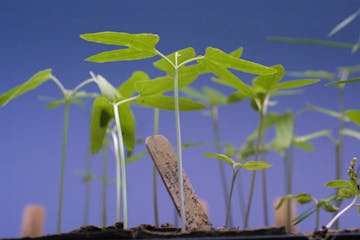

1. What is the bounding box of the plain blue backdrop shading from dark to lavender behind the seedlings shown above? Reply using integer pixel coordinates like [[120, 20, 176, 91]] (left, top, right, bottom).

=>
[[0, 0, 360, 237]]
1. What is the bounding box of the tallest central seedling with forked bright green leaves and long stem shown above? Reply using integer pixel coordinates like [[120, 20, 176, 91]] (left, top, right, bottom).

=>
[[81, 32, 275, 231]]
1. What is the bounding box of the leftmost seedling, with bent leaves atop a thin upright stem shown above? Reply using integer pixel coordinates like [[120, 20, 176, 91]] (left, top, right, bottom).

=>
[[0, 69, 99, 233]]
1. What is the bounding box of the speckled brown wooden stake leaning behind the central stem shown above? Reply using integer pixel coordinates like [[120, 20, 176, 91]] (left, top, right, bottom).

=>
[[145, 135, 212, 231]]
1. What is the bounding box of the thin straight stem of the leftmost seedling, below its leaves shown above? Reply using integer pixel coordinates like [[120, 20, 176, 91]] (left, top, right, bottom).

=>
[[57, 101, 70, 233]]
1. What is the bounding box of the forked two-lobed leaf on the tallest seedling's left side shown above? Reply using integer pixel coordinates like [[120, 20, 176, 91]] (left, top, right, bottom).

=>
[[80, 32, 159, 63]]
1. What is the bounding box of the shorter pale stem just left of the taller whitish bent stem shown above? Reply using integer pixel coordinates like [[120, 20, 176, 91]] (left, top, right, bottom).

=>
[[111, 131, 121, 222]]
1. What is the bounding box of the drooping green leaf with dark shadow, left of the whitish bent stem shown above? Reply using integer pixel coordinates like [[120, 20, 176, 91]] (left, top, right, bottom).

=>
[[90, 97, 114, 154]]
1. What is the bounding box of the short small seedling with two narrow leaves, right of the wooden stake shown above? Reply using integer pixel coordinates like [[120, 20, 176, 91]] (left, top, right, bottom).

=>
[[204, 153, 271, 227]]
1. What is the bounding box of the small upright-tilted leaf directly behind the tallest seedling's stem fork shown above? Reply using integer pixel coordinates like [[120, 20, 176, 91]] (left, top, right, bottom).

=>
[[153, 47, 196, 75]]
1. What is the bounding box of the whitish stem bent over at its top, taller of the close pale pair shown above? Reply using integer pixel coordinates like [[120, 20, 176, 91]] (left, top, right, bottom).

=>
[[113, 103, 128, 229]]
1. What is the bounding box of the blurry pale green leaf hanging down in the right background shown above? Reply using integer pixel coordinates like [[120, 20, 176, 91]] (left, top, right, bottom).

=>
[[268, 113, 294, 152]]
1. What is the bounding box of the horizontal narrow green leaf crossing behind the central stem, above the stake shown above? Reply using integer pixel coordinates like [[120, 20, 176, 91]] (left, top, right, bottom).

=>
[[136, 95, 205, 111]]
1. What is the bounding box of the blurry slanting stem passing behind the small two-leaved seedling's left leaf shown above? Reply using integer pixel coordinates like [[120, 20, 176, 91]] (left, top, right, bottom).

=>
[[210, 106, 232, 225]]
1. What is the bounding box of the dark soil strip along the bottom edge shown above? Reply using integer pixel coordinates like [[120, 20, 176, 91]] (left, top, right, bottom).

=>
[[3, 223, 360, 240]]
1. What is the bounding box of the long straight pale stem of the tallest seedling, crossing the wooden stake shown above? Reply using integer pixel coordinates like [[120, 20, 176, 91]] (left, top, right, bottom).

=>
[[174, 52, 186, 231]]
